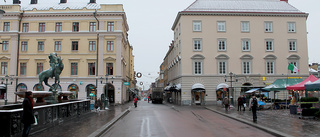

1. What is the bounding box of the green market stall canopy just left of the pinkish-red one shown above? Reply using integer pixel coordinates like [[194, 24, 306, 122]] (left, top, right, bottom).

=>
[[262, 78, 303, 91]]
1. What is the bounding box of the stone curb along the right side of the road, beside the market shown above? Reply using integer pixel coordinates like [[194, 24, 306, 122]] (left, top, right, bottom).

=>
[[205, 107, 293, 137]]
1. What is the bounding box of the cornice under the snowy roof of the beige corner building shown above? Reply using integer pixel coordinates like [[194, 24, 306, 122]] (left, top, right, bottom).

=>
[[171, 11, 309, 31]]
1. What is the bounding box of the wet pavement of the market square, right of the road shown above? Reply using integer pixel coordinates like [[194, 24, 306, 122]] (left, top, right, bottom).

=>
[[207, 106, 320, 137]]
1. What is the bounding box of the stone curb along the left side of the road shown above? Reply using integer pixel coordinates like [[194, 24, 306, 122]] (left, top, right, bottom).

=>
[[88, 109, 130, 137]]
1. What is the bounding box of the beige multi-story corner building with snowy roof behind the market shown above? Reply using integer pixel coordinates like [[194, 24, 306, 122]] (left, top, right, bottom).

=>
[[164, 0, 309, 105]]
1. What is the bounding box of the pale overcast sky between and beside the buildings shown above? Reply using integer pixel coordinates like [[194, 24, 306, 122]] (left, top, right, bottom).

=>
[[105, 0, 320, 89]]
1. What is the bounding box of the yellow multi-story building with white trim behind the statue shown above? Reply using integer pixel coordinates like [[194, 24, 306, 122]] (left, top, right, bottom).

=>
[[0, 0, 136, 104]]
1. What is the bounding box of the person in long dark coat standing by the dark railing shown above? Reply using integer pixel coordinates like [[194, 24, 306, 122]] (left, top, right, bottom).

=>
[[21, 91, 35, 137]]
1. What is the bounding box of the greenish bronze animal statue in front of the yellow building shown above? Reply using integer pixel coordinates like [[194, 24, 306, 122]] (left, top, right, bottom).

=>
[[39, 53, 63, 91]]
